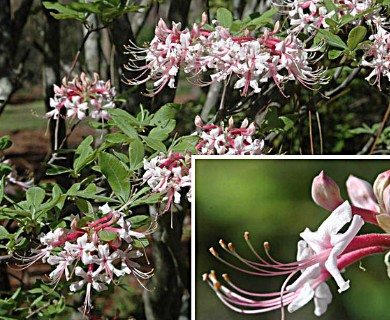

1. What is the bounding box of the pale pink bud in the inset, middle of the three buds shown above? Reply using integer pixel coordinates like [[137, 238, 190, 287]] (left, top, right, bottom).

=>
[[346, 175, 379, 212]]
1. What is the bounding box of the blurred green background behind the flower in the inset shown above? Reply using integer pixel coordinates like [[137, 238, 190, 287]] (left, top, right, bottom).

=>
[[195, 159, 390, 320]]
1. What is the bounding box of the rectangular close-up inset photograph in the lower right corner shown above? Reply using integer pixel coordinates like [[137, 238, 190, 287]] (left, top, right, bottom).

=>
[[197, 158, 390, 320]]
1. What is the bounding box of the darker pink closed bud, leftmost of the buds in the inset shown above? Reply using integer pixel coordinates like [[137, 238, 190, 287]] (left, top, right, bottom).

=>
[[311, 171, 344, 211]]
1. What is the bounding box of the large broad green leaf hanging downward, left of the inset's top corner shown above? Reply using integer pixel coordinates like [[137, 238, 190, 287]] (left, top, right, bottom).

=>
[[98, 152, 130, 202]]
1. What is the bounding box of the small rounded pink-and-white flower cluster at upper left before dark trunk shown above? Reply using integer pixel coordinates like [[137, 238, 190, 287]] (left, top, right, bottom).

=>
[[46, 73, 115, 120]]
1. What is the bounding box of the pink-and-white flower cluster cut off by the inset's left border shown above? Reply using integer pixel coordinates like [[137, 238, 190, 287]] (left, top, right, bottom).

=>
[[143, 152, 191, 213]]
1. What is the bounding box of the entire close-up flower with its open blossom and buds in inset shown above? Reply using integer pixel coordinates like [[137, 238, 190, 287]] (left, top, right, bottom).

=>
[[204, 170, 390, 318]]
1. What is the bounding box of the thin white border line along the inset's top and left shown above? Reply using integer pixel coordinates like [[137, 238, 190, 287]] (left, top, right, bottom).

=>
[[190, 155, 390, 320]]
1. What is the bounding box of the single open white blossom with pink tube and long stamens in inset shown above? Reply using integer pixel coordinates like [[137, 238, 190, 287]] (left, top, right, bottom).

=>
[[203, 202, 390, 318]]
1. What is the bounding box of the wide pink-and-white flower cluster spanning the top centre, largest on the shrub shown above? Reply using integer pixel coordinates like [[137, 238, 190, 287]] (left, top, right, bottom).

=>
[[127, 14, 327, 96]]
